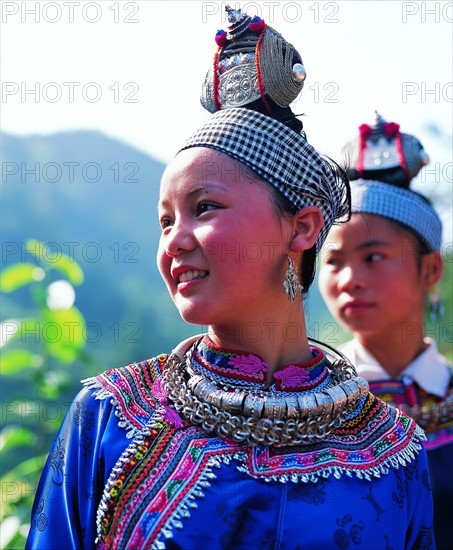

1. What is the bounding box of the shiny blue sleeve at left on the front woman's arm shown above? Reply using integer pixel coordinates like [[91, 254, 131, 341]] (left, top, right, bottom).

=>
[[26, 389, 122, 550]]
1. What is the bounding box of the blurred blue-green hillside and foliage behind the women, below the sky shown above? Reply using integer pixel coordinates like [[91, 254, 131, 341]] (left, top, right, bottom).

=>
[[0, 132, 453, 548]]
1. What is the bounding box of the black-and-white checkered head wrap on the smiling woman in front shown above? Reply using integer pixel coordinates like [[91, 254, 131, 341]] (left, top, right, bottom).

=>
[[181, 108, 349, 251]]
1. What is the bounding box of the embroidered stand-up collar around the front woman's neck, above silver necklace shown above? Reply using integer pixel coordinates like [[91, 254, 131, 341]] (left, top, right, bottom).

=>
[[191, 336, 330, 392]]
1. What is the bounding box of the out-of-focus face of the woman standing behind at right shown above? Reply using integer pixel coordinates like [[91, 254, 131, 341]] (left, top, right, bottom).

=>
[[319, 214, 428, 338]]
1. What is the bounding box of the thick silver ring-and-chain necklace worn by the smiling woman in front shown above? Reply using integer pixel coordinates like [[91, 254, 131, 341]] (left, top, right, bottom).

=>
[[162, 342, 369, 446]]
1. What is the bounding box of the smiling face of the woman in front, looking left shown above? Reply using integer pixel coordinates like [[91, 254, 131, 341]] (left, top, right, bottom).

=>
[[157, 148, 291, 325]]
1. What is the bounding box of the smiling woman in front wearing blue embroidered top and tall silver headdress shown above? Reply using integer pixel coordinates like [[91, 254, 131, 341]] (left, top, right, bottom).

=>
[[28, 9, 432, 550]]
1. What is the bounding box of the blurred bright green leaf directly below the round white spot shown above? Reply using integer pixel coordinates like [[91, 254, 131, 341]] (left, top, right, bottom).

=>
[[42, 307, 86, 363]]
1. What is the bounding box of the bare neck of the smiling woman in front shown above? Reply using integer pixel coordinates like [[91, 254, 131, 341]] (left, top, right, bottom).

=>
[[209, 304, 312, 380]]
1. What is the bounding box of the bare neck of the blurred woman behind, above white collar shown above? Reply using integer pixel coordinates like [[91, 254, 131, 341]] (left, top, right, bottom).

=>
[[354, 322, 428, 377]]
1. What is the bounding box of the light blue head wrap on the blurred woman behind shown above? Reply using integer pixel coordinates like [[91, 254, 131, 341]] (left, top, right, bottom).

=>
[[351, 179, 442, 252]]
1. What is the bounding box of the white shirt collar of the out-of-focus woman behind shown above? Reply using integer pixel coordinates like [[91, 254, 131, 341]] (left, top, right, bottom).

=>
[[341, 338, 452, 398]]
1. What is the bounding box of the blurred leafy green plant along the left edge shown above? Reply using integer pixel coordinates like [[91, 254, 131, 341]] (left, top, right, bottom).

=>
[[0, 240, 86, 548]]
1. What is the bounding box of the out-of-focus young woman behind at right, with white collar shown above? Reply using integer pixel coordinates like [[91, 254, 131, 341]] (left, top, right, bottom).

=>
[[319, 117, 453, 549]]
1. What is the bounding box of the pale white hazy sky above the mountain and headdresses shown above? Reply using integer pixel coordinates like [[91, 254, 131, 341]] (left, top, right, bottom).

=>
[[0, 0, 453, 170]]
